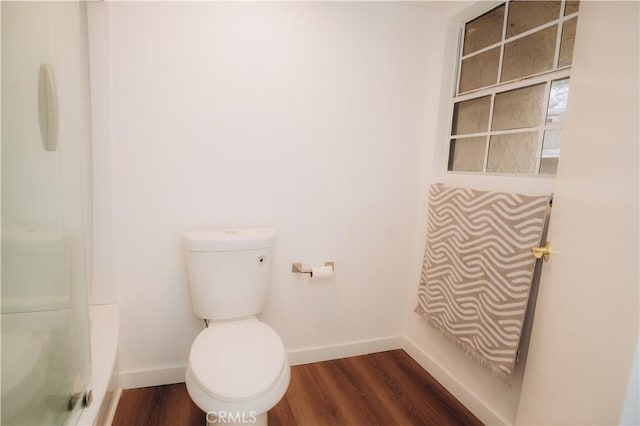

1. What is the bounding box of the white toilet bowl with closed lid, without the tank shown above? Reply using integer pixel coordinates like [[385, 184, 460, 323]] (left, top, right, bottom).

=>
[[186, 318, 290, 425]]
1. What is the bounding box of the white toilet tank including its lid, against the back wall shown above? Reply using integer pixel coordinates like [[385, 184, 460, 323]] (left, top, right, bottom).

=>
[[182, 228, 276, 320]]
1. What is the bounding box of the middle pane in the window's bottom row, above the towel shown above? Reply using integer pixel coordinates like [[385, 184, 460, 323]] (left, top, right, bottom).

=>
[[487, 132, 538, 174]]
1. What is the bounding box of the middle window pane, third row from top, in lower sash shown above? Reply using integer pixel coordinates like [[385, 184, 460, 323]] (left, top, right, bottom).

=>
[[491, 83, 545, 130]]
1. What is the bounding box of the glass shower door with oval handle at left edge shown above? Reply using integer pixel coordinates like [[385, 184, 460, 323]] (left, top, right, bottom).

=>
[[0, 1, 91, 425]]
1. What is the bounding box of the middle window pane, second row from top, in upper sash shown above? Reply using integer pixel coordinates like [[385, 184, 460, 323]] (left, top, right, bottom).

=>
[[502, 25, 558, 81]]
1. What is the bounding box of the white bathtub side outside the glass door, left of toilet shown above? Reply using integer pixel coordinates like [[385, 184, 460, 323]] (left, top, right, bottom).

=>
[[78, 304, 120, 426]]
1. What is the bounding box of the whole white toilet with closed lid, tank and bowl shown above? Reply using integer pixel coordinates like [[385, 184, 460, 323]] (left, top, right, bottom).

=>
[[183, 228, 291, 426]]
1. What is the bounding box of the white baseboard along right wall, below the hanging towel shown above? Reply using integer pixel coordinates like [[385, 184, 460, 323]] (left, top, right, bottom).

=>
[[402, 337, 509, 425]]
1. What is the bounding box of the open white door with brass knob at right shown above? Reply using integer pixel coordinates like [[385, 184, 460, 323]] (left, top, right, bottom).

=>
[[517, 2, 640, 425]]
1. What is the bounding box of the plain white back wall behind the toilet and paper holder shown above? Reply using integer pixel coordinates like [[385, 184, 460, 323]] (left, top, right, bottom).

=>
[[96, 3, 444, 386]]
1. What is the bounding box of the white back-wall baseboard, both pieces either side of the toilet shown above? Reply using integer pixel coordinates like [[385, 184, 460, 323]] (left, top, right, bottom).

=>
[[120, 336, 404, 389]]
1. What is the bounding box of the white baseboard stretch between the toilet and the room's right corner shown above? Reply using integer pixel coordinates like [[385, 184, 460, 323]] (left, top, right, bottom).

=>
[[287, 336, 404, 365]]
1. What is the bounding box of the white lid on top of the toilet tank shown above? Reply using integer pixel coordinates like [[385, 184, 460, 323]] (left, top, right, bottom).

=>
[[182, 227, 276, 251]]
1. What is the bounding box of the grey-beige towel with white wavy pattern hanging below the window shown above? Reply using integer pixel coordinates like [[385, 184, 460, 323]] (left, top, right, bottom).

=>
[[415, 184, 550, 383]]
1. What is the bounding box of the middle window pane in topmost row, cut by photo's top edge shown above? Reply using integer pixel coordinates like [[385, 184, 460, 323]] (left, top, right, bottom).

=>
[[507, 1, 560, 38]]
